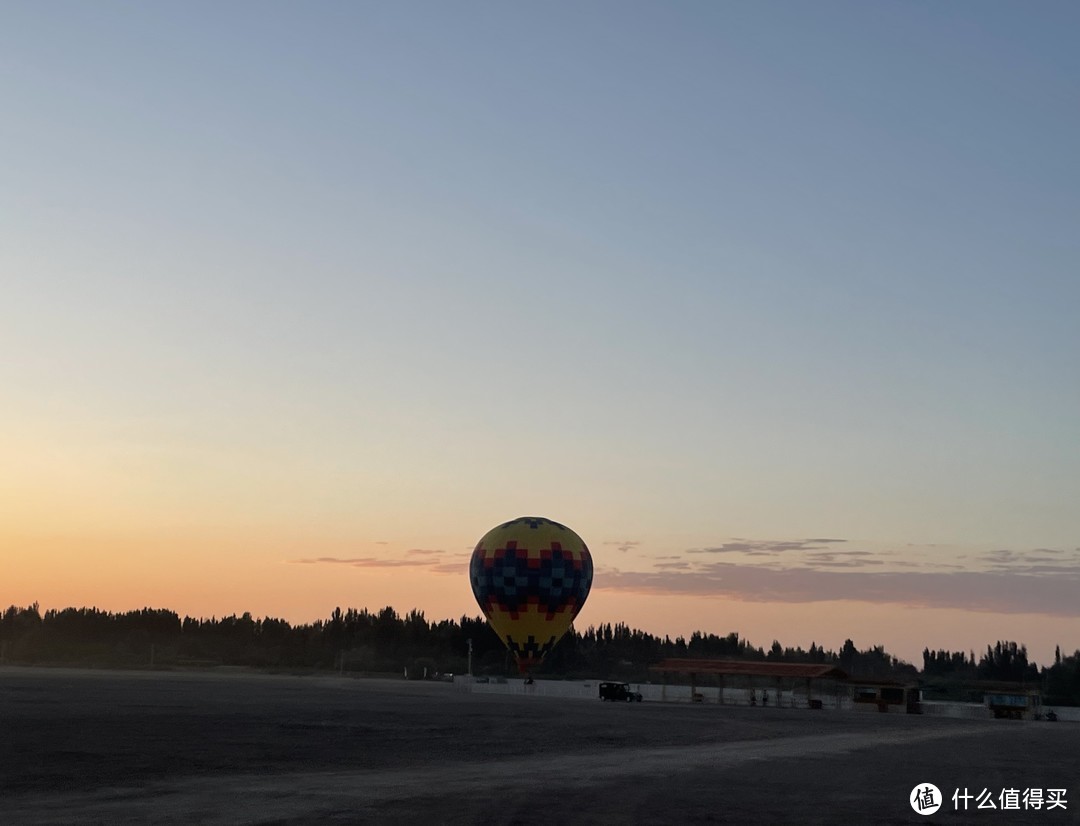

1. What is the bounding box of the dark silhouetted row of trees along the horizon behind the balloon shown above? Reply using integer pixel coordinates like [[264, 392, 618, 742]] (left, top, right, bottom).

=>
[[0, 604, 1080, 705]]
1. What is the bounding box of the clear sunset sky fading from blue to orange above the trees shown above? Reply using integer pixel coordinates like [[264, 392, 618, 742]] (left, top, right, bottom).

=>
[[0, 0, 1080, 665]]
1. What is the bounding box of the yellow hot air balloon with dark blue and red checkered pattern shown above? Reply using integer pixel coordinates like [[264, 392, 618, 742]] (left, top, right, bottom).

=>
[[469, 516, 593, 674]]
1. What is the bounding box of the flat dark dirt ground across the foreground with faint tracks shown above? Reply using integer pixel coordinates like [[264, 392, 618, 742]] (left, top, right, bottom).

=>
[[0, 666, 1080, 825]]
